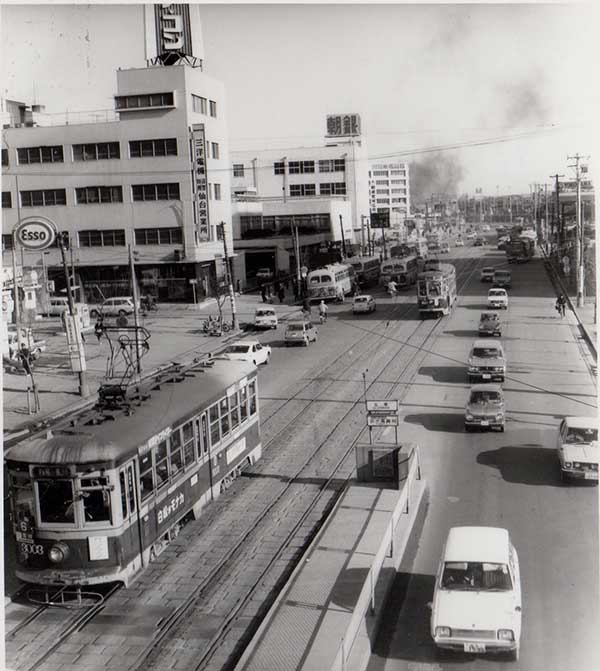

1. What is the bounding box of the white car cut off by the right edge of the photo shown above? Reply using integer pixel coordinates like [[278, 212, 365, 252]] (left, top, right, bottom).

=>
[[556, 417, 599, 483]]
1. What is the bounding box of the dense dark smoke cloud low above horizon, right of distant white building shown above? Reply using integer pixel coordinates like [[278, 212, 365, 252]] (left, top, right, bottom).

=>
[[409, 152, 464, 205]]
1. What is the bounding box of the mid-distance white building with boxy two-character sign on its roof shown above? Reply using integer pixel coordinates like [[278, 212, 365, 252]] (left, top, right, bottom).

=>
[[231, 115, 369, 278]]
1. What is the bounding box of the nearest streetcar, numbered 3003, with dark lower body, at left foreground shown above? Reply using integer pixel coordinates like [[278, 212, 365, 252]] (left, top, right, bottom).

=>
[[5, 360, 262, 589]]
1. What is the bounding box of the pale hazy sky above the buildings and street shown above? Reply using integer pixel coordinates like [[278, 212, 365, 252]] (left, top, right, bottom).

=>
[[1, 2, 600, 194]]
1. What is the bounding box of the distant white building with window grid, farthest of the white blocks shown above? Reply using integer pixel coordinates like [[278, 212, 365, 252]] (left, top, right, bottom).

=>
[[369, 161, 410, 227]]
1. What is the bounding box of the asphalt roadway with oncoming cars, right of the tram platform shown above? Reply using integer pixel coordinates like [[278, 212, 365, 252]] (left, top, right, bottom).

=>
[[360, 240, 600, 671]]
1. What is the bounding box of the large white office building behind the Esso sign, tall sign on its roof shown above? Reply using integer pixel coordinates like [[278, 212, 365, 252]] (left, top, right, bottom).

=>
[[2, 5, 232, 300]]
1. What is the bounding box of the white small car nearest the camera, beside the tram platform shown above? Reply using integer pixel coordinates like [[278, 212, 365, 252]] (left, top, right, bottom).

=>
[[430, 526, 522, 660]]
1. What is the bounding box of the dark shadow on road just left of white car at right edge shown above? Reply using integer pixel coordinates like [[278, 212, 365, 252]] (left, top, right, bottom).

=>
[[477, 444, 562, 487]]
